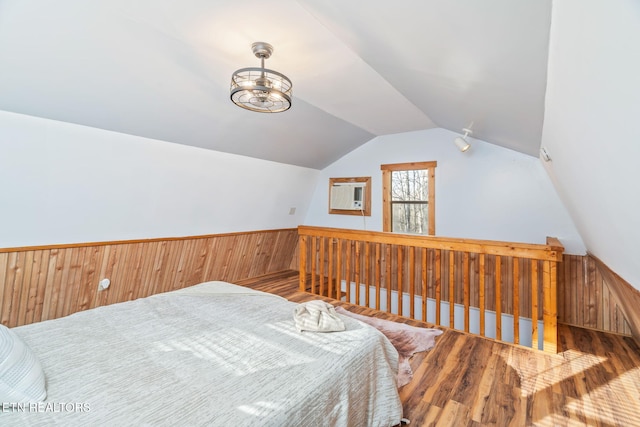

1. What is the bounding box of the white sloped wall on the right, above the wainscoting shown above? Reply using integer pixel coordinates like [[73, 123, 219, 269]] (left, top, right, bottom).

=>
[[542, 0, 640, 289]]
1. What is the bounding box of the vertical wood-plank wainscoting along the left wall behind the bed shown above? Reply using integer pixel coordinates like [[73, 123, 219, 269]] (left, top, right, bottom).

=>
[[0, 229, 298, 327]]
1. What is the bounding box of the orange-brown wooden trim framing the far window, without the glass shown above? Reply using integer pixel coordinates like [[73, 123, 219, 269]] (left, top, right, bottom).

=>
[[380, 161, 438, 236]]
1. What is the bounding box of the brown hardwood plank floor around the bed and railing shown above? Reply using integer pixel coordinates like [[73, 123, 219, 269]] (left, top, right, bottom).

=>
[[236, 270, 640, 427]]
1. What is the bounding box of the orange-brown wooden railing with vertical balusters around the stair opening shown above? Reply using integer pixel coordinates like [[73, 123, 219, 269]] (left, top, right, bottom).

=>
[[298, 226, 564, 353]]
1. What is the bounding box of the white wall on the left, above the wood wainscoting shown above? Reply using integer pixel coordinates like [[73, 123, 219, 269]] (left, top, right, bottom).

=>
[[0, 111, 319, 247]]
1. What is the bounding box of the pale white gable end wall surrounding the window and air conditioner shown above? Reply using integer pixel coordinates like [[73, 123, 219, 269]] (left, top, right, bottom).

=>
[[305, 129, 585, 254]]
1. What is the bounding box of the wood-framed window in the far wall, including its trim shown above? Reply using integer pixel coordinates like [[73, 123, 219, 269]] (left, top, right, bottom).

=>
[[380, 162, 437, 235]]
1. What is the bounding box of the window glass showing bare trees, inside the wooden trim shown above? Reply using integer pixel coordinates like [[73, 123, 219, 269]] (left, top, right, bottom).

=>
[[391, 169, 429, 234]]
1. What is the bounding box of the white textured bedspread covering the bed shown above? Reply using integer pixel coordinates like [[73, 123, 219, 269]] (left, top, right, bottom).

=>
[[0, 282, 402, 426]]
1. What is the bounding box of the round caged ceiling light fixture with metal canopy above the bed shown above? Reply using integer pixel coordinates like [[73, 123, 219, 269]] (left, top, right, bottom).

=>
[[231, 42, 292, 113]]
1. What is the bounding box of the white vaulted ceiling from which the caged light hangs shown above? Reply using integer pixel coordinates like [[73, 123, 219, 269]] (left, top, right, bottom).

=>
[[0, 0, 551, 169]]
